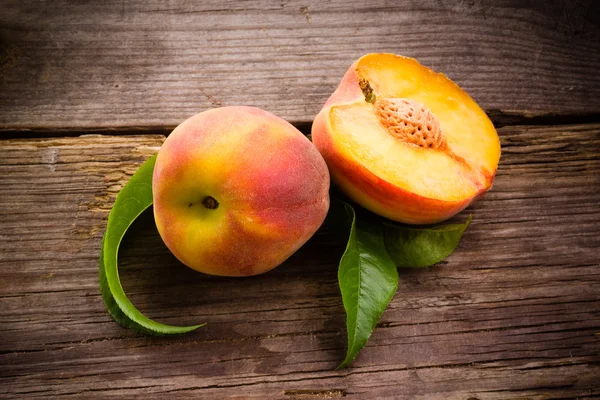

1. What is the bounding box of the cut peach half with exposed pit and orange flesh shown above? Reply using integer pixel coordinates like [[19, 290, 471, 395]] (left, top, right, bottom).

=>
[[312, 54, 500, 224]]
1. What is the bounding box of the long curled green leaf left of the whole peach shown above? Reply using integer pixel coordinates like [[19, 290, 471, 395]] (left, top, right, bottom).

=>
[[100, 155, 204, 335]]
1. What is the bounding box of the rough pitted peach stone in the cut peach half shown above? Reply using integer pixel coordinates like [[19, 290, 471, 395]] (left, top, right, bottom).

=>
[[375, 98, 446, 149]]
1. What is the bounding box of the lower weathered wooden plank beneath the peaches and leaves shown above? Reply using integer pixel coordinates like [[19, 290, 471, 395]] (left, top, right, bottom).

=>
[[0, 124, 600, 400]]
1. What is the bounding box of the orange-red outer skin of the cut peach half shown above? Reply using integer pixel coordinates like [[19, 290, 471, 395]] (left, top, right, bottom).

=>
[[311, 61, 494, 224]]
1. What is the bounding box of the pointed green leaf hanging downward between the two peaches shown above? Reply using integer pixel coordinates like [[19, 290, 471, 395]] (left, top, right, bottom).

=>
[[338, 204, 398, 368]]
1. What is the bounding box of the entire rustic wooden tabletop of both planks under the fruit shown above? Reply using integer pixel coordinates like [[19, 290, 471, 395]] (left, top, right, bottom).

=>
[[0, 0, 600, 400]]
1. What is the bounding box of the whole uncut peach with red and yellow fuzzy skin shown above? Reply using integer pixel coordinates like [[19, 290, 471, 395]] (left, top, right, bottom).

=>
[[152, 107, 329, 276]]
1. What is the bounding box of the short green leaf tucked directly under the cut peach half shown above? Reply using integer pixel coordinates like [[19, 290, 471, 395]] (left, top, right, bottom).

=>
[[384, 216, 472, 267]]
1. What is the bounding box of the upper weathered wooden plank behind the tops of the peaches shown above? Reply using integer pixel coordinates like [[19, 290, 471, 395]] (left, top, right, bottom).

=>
[[0, 0, 600, 130]]
